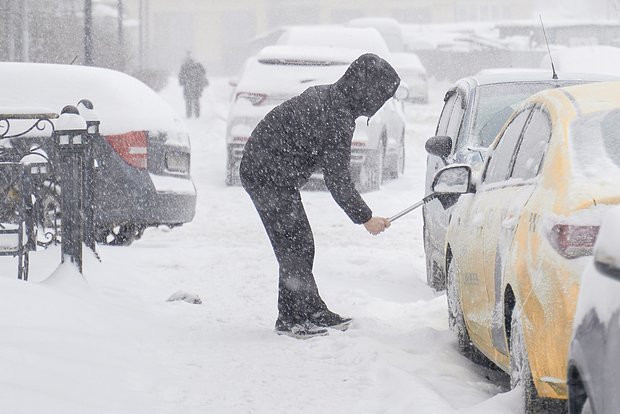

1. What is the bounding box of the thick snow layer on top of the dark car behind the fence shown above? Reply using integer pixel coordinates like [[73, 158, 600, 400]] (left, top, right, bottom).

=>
[[0, 62, 185, 134]]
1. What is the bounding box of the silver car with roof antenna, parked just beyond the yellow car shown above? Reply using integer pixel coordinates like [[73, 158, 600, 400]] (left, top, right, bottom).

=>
[[423, 70, 612, 290]]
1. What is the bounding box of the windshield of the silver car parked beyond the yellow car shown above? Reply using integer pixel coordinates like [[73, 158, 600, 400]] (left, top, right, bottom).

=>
[[471, 82, 576, 148]]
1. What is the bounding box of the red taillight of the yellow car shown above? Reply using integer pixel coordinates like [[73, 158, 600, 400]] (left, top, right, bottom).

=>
[[549, 224, 599, 259]]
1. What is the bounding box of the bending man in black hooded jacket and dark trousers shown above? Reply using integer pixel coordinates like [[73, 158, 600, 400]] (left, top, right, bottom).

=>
[[240, 53, 400, 337]]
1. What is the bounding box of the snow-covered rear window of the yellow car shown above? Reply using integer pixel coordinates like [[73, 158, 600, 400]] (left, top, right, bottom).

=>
[[570, 109, 620, 184]]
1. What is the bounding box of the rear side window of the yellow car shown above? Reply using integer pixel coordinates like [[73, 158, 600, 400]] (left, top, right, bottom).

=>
[[511, 108, 551, 180]]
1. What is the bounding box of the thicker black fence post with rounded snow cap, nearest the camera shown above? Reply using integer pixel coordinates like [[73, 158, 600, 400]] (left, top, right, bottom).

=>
[[54, 105, 87, 273]]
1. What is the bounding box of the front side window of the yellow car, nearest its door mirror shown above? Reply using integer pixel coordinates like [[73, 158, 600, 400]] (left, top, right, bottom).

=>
[[484, 108, 531, 183]]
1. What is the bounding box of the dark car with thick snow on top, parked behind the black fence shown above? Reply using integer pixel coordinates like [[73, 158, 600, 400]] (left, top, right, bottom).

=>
[[0, 62, 196, 244]]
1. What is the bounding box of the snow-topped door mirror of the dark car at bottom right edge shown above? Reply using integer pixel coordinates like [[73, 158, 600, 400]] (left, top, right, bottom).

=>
[[594, 208, 620, 280]]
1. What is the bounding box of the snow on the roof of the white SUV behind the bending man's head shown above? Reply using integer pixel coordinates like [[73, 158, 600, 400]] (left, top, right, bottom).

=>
[[278, 26, 390, 58]]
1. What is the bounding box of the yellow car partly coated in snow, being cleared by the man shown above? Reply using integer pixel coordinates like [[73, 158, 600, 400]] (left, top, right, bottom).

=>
[[438, 82, 620, 413]]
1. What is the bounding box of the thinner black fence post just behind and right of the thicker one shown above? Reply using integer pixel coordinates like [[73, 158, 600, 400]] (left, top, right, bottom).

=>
[[77, 99, 101, 253]]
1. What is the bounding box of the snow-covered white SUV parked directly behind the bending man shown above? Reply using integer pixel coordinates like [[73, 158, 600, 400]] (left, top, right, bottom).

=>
[[226, 27, 406, 191]]
